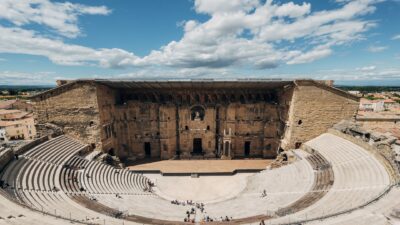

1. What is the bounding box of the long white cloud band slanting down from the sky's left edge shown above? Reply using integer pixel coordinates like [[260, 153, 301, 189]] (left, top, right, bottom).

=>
[[0, 26, 140, 67]]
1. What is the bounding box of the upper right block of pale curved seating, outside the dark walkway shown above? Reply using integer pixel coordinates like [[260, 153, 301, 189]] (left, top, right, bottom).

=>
[[272, 133, 391, 224]]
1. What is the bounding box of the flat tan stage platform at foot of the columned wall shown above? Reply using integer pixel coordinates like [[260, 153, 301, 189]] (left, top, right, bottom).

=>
[[128, 159, 273, 176]]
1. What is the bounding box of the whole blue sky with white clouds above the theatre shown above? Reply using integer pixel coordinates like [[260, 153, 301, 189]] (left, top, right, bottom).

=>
[[0, 0, 400, 85]]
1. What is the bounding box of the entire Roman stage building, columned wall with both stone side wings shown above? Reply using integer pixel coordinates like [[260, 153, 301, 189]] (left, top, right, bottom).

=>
[[33, 80, 358, 159]]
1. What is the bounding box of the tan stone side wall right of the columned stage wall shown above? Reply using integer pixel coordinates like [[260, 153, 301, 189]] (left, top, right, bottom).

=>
[[281, 80, 359, 149]]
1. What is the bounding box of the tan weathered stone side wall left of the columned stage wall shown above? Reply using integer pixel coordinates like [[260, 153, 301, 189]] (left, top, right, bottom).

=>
[[32, 82, 102, 149]]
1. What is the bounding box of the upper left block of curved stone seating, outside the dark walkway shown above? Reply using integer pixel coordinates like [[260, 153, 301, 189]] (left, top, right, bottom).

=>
[[1, 136, 150, 224]]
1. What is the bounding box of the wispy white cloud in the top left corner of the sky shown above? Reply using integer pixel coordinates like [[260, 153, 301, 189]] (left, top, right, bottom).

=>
[[0, 0, 110, 38]]
